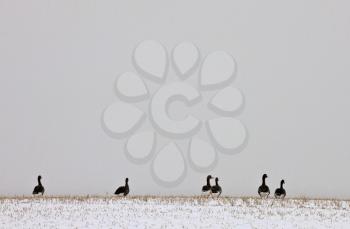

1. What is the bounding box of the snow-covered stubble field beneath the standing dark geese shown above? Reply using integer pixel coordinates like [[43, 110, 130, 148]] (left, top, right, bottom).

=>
[[0, 197, 350, 229]]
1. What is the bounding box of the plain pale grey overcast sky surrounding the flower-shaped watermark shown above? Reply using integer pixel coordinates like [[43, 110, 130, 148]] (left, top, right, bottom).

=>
[[0, 0, 350, 198]]
